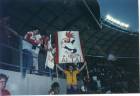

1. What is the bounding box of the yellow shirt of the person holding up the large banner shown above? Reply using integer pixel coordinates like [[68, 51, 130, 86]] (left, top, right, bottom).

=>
[[64, 70, 79, 85]]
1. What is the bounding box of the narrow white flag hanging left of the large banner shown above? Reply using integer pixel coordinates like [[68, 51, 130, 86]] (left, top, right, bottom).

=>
[[45, 35, 54, 69]]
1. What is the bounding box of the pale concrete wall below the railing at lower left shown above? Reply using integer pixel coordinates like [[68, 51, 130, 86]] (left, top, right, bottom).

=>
[[0, 69, 66, 95]]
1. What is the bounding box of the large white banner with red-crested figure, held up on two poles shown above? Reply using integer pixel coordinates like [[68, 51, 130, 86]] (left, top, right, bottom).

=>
[[55, 31, 84, 63]]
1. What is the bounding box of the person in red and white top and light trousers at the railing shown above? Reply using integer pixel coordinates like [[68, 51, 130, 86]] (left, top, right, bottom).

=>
[[23, 26, 42, 72]]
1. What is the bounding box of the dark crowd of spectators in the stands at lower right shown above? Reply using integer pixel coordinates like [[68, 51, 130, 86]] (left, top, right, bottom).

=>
[[80, 63, 138, 93]]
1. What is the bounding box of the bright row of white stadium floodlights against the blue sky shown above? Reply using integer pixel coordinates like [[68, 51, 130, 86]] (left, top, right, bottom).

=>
[[105, 14, 129, 28]]
